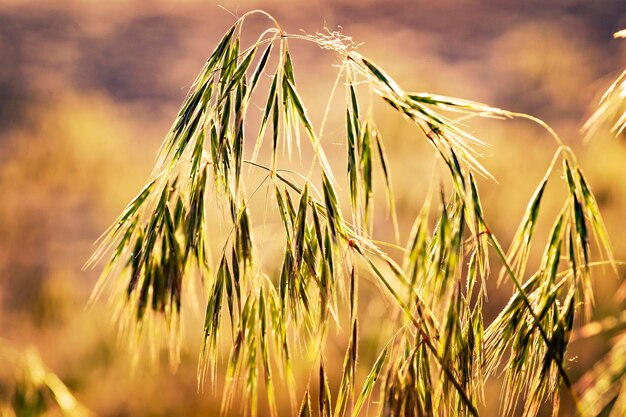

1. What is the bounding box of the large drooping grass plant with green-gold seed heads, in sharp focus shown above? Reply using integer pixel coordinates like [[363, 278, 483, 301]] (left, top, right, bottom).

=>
[[86, 11, 625, 417]]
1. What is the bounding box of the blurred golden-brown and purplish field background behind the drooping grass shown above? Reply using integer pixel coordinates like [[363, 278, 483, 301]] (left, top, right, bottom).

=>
[[0, 0, 626, 417]]
